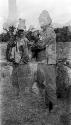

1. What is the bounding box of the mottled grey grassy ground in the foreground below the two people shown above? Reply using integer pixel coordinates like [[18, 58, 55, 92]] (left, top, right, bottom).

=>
[[0, 63, 65, 125]]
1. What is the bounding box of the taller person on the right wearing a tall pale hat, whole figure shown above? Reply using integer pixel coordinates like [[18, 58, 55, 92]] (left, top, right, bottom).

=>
[[32, 10, 57, 111]]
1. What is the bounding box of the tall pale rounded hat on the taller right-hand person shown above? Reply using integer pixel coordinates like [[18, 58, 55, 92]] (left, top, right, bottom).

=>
[[39, 10, 52, 26]]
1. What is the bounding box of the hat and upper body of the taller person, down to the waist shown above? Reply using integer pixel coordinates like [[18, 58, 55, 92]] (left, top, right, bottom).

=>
[[39, 10, 56, 64]]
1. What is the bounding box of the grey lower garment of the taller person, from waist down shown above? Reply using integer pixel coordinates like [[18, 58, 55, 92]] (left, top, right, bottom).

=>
[[37, 63, 57, 104]]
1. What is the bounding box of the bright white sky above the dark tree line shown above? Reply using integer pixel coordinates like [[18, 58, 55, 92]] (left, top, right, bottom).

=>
[[0, 0, 71, 30]]
